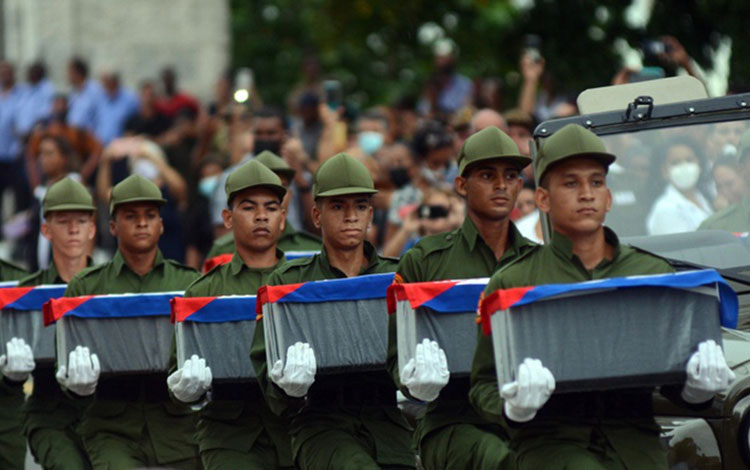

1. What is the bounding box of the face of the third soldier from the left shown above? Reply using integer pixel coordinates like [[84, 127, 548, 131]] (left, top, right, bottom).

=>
[[222, 188, 286, 253]]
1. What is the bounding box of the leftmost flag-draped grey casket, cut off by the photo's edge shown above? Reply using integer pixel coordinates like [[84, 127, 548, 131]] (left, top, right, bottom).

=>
[[0, 283, 65, 363]]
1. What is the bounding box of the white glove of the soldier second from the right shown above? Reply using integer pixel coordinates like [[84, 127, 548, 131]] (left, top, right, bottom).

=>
[[400, 339, 451, 402]]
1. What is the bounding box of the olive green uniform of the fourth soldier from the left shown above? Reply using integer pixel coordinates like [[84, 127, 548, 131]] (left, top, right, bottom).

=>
[[251, 242, 414, 468]]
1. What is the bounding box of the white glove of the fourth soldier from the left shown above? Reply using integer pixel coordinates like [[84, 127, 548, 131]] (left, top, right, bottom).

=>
[[268, 343, 318, 398]]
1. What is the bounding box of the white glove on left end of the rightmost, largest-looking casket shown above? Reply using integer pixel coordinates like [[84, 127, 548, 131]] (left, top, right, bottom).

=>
[[500, 358, 555, 423]]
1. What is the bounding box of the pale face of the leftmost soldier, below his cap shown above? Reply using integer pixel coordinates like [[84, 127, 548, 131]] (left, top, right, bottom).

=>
[[41, 211, 96, 258]]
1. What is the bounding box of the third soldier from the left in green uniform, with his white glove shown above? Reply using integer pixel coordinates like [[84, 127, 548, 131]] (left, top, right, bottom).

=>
[[168, 160, 293, 470]]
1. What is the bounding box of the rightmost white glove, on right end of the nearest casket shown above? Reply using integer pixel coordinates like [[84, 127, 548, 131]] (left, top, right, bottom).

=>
[[682, 339, 735, 404]]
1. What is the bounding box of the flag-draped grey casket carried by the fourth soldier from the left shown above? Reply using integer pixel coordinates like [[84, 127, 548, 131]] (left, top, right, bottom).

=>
[[257, 273, 393, 374]]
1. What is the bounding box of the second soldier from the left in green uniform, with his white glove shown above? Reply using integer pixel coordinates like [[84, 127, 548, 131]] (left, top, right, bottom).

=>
[[57, 175, 200, 469]]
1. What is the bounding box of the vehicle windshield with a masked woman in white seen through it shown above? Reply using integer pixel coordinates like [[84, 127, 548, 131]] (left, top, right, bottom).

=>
[[602, 120, 750, 244]]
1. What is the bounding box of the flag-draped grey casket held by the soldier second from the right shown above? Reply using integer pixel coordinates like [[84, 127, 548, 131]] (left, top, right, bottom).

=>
[[388, 278, 488, 376]]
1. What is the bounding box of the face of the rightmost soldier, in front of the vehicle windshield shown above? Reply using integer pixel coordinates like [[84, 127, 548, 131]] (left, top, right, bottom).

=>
[[535, 157, 612, 236]]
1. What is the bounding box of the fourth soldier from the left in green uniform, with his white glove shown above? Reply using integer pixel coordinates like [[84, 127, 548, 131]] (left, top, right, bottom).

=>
[[251, 154, 415, 469]]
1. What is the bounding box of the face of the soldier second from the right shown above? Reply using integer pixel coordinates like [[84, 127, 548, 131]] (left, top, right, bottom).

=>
[[454, 160, 522, 220]]
